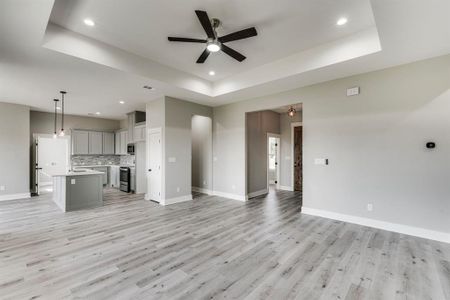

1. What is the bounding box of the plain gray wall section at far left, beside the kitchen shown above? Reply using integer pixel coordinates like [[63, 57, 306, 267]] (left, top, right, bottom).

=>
[[0, 102, 30, 196]]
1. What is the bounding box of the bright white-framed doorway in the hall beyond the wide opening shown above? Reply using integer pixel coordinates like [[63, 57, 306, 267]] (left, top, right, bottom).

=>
[[267, 133, 280, 189]]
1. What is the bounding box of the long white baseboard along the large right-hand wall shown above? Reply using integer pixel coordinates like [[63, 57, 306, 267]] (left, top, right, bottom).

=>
[[302, 207, 450, 243]]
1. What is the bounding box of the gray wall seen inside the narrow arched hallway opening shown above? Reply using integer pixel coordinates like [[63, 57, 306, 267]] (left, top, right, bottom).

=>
[[191, 116, 212, 190]]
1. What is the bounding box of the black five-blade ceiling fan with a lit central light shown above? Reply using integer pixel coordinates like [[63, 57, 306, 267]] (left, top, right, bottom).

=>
[[168, 10, 258, 64]]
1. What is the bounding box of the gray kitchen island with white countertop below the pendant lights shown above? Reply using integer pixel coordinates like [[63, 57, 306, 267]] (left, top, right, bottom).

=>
[[52, 169, 104, 212]]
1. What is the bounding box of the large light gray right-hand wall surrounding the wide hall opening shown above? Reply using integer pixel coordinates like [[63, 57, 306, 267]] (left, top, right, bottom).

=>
[[213, 56, 450, 232]]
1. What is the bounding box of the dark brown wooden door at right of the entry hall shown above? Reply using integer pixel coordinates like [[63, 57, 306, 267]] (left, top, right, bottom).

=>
[[291, 123, 303, 192]]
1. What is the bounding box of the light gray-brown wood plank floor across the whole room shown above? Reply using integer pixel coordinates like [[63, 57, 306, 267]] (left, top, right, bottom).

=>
[[0, 190, 450, 299]]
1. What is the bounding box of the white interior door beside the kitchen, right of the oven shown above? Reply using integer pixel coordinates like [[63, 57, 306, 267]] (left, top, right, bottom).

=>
[[147, 130, 162, 202]]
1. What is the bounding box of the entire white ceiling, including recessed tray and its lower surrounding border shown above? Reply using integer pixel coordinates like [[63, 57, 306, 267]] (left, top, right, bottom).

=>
[[0, 0, 450, 119]]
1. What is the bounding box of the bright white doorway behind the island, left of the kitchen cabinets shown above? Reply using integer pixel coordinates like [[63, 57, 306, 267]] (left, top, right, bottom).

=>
[[34, 134, 70, 195]]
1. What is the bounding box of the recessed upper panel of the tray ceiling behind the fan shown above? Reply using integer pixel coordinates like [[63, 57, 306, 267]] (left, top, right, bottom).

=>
[[50, 0, 375, 81]]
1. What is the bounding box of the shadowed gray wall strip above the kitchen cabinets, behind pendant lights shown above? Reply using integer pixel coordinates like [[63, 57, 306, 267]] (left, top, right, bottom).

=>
[[30, 111, 120, 139]]
